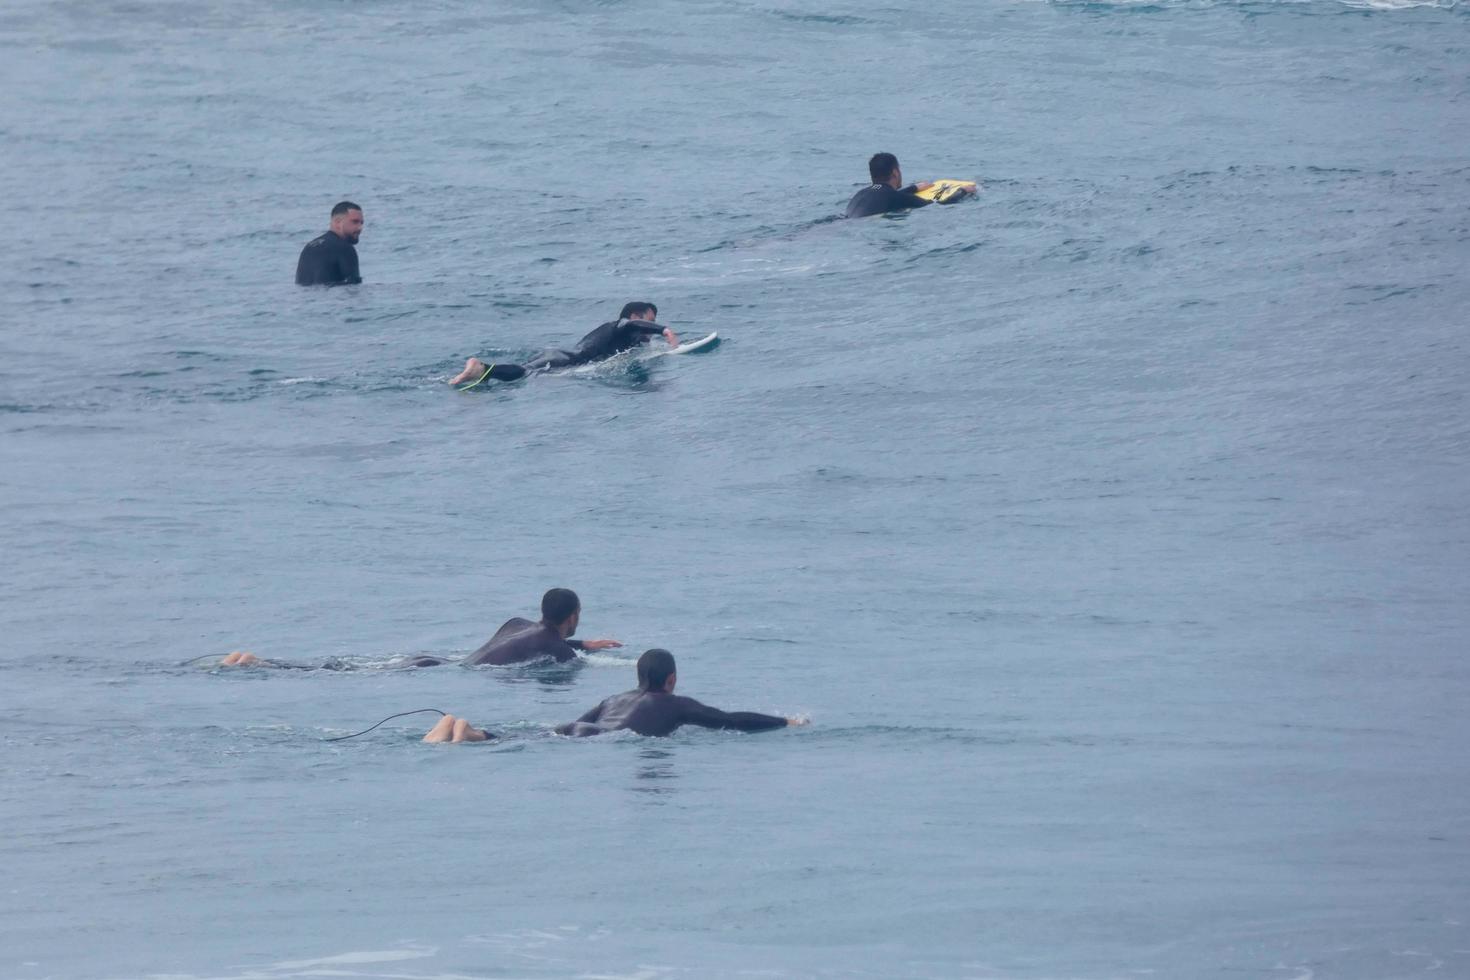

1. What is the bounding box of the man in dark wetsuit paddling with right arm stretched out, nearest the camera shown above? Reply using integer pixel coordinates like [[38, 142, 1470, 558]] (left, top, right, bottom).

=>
[[423, 649, 807, 742]]
